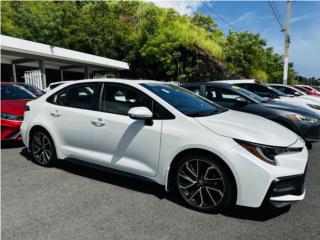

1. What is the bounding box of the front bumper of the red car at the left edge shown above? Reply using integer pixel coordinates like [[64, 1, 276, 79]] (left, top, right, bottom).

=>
[[1, 119, 22, 141]]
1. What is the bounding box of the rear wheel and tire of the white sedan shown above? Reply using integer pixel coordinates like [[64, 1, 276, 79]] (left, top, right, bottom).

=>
[[30, 130, 57, 167]]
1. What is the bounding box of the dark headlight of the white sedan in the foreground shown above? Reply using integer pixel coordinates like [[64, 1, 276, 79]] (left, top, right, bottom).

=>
[[234, 139, 289, 165]]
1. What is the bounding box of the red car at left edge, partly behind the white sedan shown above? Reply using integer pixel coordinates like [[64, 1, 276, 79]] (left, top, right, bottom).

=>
[[0, 82, 36, 141]]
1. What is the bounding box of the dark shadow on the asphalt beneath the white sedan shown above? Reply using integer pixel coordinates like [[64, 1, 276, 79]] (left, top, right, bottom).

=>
[[20, 148, 289, 221]]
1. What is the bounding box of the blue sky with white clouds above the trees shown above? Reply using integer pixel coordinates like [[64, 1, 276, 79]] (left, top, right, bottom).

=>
[[152, 0, 320, 78]]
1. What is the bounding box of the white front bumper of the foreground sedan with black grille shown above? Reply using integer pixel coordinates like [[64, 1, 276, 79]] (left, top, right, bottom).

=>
[[224, 140, 308, 207]]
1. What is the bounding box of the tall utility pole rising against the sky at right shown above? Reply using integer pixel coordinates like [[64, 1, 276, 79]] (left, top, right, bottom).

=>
[[283, 0, 291, 85]]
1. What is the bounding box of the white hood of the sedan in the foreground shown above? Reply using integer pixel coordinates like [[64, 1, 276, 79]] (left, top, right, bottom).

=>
[[196, 110, 298, 147]]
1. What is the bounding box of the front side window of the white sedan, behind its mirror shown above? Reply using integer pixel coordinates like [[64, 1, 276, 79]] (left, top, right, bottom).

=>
[[100, 84, 174, 119]]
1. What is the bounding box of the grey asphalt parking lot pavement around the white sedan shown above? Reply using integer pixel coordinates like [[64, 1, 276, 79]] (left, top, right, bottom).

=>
[[1, 144, 320, 240]]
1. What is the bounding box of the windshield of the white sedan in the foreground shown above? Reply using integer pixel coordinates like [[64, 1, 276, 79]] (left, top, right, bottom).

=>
[[141, 83, 227, 117]]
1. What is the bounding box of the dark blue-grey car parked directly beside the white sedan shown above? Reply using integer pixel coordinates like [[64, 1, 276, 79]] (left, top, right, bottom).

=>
[[182, 83, 320, 148]]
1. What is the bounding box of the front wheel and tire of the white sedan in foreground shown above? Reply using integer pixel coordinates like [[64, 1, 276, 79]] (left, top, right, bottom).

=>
[[174, 155, 235, 212]]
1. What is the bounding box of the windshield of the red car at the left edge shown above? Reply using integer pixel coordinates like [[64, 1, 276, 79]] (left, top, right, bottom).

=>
[[1, 85, 36, 100]]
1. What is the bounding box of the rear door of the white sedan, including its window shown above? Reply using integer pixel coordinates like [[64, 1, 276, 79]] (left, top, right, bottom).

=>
[[46, 83, 99, 160]]
